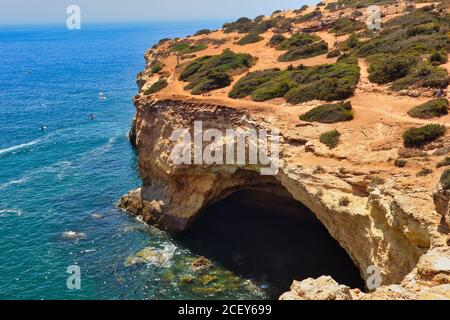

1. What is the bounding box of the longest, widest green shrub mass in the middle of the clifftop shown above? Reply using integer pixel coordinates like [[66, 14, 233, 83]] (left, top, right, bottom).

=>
[[229, 59, 359, 104]]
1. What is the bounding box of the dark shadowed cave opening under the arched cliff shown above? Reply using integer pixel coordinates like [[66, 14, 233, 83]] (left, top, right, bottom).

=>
[[179, 186, 364, 299]]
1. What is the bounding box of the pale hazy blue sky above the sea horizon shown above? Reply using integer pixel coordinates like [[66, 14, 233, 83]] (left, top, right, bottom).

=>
[[0, 0, 319, 24]]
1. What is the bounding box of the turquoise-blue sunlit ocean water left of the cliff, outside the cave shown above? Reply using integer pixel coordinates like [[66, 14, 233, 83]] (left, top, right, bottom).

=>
[[0, 22, 265, 299]]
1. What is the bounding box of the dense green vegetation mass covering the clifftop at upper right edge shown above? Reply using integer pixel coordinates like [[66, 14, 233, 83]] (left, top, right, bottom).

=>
[[353, 7, 450, 91]]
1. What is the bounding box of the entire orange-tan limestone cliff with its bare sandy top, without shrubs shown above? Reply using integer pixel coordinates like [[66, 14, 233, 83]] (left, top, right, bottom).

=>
[[119, 0, 450, 299]]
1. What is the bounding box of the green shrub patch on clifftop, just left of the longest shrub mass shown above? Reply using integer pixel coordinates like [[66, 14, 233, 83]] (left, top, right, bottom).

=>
[[180, 50, 254, 94]]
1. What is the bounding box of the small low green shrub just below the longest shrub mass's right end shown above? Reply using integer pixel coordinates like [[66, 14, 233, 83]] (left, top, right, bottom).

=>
[[300, 102, 353, 123]]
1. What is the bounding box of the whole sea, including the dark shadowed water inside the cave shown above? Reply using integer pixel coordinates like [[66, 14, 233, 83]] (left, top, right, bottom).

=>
[[0, 21, 363, 300]]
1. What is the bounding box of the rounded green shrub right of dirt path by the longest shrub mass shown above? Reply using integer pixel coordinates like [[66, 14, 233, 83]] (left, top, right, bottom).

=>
[[368, 54, 417, 83]]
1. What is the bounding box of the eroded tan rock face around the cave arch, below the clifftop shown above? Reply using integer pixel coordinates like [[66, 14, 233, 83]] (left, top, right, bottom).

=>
[[120, 95, 450, 299]]
